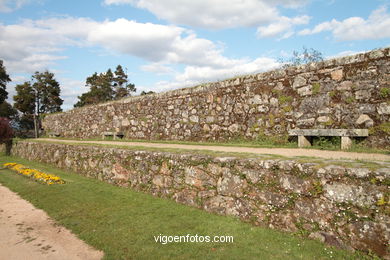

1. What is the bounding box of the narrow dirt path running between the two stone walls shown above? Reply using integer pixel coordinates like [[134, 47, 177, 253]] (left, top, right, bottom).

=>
[[39, 138, 390, 162]]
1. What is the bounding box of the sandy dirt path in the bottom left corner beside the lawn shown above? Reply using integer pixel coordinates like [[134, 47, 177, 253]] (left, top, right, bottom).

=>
[[0, 185, 103, 260]]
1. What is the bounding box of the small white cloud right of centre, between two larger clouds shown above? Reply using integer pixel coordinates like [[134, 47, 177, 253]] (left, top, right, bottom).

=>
[[257, 15, 310, 38]]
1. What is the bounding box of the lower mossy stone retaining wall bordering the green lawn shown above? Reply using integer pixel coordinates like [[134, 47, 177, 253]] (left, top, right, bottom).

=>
[[12, 141, 390, 258]]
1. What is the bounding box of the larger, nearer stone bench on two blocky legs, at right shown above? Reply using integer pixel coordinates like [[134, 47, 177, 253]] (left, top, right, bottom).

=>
[[288, 129, 368, 150]]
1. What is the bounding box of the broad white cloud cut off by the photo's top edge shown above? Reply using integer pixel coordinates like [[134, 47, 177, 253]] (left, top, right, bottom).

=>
[[104, 0, 308, 29]]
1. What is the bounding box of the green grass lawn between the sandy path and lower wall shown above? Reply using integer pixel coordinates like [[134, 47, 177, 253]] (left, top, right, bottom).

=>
[[0, 156, 372, 259]]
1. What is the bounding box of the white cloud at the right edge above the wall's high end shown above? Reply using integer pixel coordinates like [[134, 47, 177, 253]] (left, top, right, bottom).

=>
[[299, 6, 390, 41]]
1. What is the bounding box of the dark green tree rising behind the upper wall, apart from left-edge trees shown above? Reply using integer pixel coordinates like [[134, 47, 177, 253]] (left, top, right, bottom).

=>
[[74, 65, 136, 107]]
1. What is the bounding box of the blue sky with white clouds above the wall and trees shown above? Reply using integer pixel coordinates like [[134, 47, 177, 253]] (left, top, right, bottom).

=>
[[0, 0, 390, 110]]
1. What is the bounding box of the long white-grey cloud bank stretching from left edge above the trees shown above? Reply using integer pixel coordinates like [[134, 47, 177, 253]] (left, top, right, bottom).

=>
[[0, 17, 266, 72]]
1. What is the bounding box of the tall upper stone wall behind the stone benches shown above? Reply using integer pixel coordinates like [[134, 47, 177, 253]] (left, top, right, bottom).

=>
[[43, 48, 390, 146]]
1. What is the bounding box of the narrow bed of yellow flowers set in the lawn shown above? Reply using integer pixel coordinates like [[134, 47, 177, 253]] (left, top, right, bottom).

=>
[[3, 163, 65, 185]]
